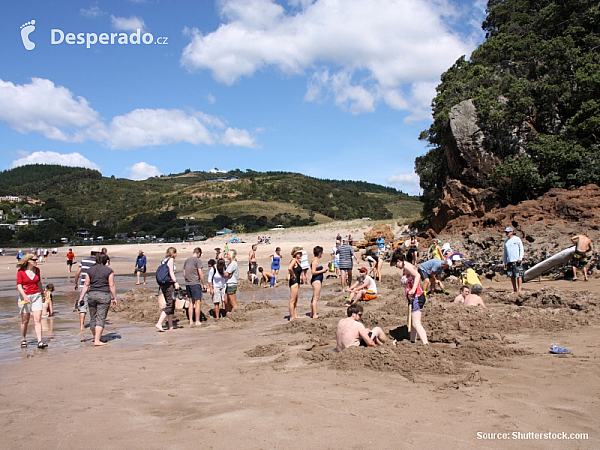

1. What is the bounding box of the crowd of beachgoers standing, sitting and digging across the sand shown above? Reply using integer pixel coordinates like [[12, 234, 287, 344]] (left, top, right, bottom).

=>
[[17, 226, 593, 351]]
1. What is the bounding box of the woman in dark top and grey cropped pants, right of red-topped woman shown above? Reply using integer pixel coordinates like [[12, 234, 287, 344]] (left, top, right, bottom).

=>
[[79, 253, 117, 347]]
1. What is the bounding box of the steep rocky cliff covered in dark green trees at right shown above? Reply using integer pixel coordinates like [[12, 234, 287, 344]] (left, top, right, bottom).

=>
[[415, 0, 600, 226]]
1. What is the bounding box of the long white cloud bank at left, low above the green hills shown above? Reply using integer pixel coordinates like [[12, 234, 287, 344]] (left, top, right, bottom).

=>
[[0, 78, 257, 149]]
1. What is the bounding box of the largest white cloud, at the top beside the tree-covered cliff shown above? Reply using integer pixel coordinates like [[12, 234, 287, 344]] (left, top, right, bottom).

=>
[[181, 0, 485, 120]]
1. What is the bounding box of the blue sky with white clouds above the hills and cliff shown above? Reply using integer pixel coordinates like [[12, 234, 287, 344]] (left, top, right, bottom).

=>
[[0, 0, 485, 194]]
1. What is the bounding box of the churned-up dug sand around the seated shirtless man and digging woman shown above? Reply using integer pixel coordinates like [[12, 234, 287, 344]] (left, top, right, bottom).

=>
[[275, 289, 599, 385]]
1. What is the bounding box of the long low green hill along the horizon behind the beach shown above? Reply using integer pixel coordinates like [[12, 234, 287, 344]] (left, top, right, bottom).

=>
[[0, 165, 422, 242]]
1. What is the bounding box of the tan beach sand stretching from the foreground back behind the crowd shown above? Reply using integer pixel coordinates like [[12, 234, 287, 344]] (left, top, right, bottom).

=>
[[0, 222, 600, 449]]
